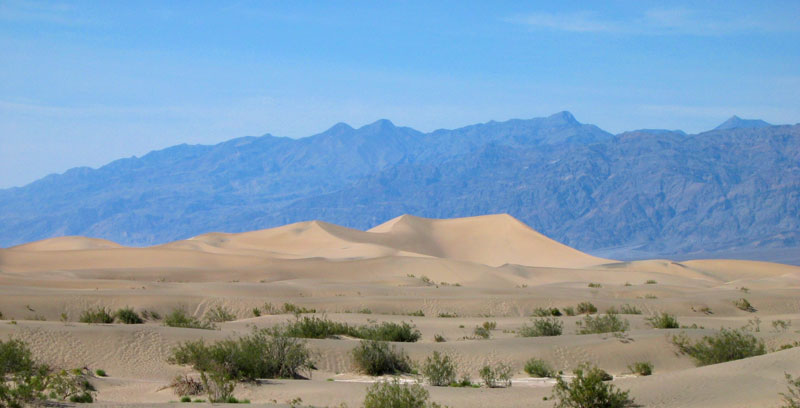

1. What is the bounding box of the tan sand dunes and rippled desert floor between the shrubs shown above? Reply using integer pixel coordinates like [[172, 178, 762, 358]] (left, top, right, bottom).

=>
[[0, 215, 800, 407]]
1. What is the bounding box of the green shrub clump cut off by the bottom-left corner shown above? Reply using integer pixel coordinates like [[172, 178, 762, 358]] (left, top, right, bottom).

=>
[[0, 339, 95, 407]]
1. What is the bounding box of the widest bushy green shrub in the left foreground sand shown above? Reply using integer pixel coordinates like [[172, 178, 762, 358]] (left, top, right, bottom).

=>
[[169, 328, 314, 380]]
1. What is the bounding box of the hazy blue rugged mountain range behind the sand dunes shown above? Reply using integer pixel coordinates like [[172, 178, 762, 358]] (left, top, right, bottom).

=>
[[0, 112, 800, 262]]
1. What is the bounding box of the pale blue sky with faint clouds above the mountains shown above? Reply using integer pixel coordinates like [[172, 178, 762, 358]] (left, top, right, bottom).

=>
[[0, 0, 800, 188]]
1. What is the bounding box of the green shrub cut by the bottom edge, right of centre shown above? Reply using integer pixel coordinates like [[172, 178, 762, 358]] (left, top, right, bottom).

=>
[[553, 365, 634, 408]]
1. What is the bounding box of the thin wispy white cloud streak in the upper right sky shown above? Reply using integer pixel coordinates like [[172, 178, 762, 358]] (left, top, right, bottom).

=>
[[506, 8, 800, 35]]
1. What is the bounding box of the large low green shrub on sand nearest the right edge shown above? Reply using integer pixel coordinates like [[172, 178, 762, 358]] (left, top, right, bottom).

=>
[[672, 327, 766, 366]]
